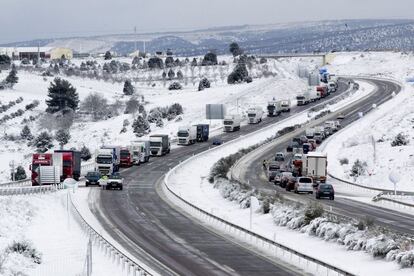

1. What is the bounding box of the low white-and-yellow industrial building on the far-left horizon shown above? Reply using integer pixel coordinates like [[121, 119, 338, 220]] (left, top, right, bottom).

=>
[[0, 47, 73, 60]]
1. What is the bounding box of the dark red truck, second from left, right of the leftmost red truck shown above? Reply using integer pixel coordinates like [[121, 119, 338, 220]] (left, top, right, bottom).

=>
[[53, 150, 81, 181]]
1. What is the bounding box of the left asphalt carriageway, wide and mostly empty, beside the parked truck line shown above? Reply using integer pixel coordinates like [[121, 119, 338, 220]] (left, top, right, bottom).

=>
[[90, 78, 348, 275]]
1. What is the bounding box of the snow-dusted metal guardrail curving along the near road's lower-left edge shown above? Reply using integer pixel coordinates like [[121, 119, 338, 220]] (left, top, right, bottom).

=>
[[69, 192, 154, 276]]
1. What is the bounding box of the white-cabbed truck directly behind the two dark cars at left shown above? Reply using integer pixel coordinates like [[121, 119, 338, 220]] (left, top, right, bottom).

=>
[[95, 146, 121, 175]]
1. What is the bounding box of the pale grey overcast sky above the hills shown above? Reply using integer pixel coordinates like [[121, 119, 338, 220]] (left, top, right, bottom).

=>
[[0, 0, 414, 43]]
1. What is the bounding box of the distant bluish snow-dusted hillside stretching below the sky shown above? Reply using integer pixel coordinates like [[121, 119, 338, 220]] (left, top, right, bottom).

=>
[[3, 20, 414, 56]]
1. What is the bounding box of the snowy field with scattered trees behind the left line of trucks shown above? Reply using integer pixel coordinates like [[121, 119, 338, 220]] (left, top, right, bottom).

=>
[[0, 56, 310, 182]]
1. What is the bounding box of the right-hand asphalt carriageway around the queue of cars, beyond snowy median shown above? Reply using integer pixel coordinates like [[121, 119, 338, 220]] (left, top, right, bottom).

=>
[[242, 78, 414, 235]]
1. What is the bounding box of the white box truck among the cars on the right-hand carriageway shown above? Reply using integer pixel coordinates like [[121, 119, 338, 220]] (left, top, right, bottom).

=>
[[302, 152, 328, 183]]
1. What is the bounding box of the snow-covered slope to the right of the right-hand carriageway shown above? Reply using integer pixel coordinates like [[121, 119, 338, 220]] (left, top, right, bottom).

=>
[[324, 53, 414, 191]]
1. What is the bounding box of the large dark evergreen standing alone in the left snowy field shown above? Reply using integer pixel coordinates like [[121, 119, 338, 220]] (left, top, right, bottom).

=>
[[46, 78, 79, 113]]
